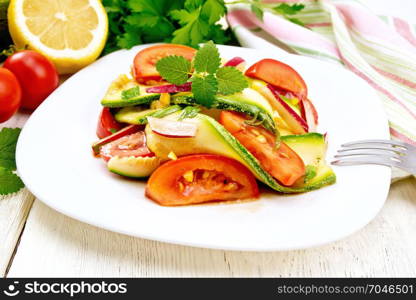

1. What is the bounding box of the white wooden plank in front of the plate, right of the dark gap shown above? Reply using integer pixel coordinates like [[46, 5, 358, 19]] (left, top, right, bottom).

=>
[[9, 178, 416, 277]]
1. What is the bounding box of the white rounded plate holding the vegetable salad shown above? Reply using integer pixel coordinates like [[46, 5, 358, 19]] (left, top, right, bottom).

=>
[[17, 46, 390, 251]]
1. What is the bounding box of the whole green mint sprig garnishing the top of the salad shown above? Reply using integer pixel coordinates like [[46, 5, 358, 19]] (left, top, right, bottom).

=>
[[156, 41, 248, 107]]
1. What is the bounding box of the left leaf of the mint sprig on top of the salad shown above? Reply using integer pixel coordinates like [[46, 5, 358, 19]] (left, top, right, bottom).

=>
[[156, 55, 191, 85]]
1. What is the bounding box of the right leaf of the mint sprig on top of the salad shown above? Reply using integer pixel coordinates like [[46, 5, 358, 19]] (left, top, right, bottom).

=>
[[216, 67, 248, 95]]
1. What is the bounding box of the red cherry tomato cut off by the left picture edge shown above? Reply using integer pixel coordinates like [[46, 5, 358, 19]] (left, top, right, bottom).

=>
[[0, 68, 22, 123]]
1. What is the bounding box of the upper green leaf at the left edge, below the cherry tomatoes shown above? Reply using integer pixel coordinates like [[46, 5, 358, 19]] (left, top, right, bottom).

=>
[[0, 128, 21, 170]]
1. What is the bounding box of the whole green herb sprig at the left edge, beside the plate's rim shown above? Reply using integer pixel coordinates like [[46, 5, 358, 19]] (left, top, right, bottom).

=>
[[0, 128, 24, 195]]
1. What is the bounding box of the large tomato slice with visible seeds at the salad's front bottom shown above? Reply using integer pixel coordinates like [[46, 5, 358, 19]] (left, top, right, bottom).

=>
[[146, 154, 259, 206]]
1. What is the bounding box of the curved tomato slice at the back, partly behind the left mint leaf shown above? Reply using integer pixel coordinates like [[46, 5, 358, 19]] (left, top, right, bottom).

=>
[[133, 44, 196, 84]]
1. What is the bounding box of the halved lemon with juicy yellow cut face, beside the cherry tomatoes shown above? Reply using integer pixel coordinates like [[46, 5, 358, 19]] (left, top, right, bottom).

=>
[[8, 0, 108, 74]]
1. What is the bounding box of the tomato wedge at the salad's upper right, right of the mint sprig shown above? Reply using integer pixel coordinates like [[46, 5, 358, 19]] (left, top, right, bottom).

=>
[[246, 58, 308, 99]]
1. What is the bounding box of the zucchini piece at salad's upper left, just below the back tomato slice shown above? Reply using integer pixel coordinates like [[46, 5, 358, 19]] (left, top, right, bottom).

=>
[[101, 74, 160, 107]]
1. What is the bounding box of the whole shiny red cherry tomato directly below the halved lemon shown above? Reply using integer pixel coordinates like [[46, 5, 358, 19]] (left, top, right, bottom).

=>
[[4, 50, 59, 110]]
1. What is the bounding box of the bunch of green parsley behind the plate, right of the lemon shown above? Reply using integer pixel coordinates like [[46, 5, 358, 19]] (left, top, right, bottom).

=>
[[103, 0, 232, 53]]
